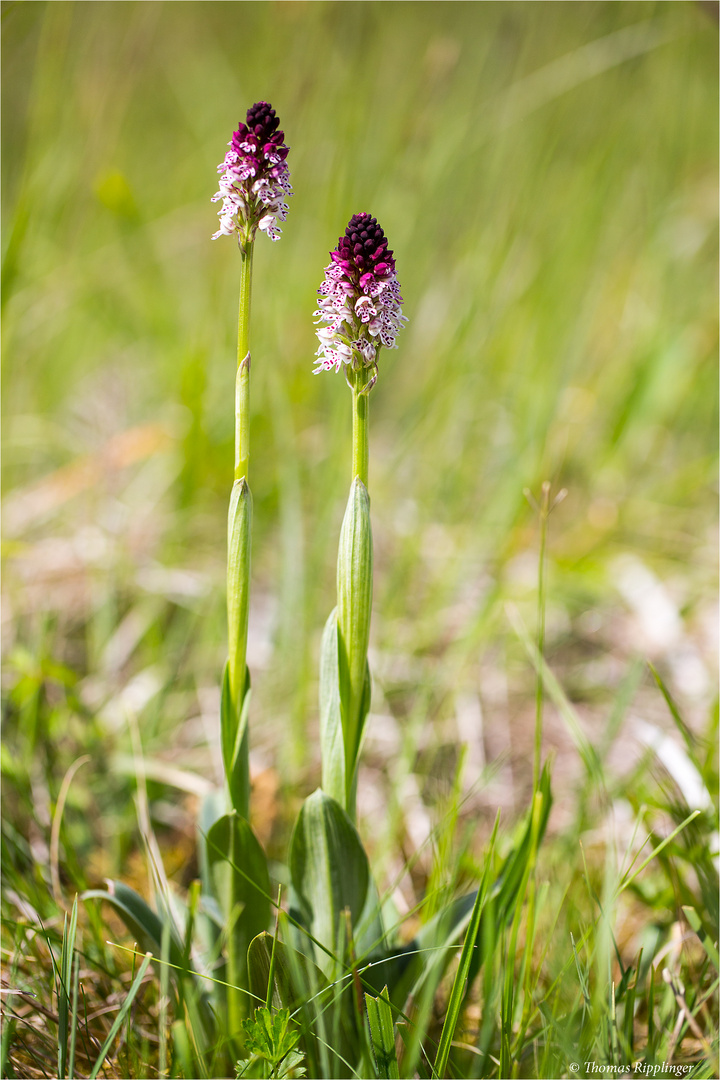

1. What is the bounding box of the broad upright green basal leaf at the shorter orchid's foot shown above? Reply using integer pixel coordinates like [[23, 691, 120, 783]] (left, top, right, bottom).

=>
[[289, 788, 370, 977]]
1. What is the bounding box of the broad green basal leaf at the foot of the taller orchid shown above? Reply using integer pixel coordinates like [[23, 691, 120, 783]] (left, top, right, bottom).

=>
[[207, 811, 270, 1021]]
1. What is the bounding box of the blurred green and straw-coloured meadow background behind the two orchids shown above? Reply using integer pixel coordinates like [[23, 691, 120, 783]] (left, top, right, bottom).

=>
[[2, 0, 718, 877]]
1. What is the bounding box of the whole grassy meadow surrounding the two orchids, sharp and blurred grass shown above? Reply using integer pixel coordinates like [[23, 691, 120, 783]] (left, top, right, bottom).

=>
[[0, 2, 718, 1077]]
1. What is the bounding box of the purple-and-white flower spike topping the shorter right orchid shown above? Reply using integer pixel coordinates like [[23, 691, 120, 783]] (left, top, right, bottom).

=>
[[314, 214, 407, 392]]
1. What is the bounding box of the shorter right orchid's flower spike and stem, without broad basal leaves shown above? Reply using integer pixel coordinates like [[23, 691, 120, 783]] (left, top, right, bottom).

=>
[[315, 213, 407, 819]]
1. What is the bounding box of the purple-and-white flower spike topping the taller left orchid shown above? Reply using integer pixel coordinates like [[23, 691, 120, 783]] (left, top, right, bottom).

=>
[[213, 102, 293, 246]]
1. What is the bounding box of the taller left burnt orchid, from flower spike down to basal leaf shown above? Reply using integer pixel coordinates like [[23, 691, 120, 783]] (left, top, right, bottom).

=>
[[205, 102, 291, 1035]]
